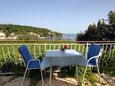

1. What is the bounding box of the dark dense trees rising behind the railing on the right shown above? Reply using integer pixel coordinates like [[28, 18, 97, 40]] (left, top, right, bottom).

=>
[[77, 11, 115, 41]]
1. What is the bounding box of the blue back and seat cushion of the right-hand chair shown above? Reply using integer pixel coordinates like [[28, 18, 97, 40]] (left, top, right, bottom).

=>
[[87, 44, 101, 65]]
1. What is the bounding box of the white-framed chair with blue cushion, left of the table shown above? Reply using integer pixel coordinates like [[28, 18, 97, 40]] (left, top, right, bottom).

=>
[[19, 45, 44, 86]]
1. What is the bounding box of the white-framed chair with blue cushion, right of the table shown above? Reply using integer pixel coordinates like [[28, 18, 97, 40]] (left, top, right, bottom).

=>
[[82, 44, 102, 84]]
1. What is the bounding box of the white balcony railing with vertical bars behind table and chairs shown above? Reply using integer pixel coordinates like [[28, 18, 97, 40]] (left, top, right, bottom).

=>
[[0, 43, 115, 73]]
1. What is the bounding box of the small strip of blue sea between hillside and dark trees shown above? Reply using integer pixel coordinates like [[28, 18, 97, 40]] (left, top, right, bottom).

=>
[[62, 33, 77, 41]]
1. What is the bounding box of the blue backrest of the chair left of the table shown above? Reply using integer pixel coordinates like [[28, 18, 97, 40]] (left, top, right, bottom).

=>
[[19, 45, 31, 66]]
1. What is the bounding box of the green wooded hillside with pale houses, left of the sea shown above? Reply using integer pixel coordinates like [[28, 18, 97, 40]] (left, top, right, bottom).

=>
[[0, 24, 62, 38]]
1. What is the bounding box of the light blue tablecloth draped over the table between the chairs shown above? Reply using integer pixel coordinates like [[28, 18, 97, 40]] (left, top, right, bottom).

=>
[[41, 50, 87, 70]]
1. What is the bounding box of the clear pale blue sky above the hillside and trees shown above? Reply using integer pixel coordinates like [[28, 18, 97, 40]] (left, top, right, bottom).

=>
[[0, 0, 115, 33]]
